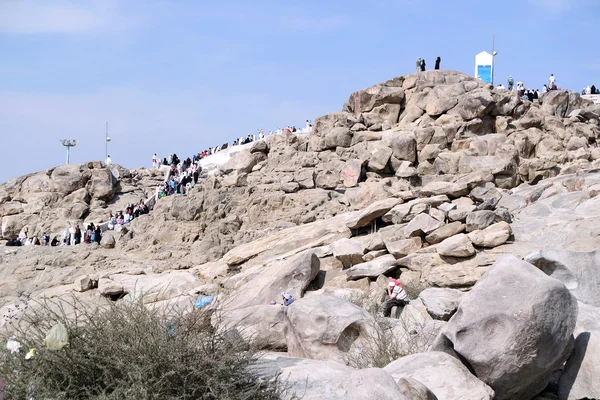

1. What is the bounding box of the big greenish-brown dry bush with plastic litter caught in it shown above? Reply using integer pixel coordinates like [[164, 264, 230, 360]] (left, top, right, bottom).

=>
[[0, 299, 279, 400]]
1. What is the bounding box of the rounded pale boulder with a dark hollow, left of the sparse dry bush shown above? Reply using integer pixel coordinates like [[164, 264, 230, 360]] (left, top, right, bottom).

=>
[[285, 295, 373, 362]]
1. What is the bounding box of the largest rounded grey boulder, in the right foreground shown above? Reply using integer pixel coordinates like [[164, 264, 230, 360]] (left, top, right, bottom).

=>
[[433, 256, 577, 400]]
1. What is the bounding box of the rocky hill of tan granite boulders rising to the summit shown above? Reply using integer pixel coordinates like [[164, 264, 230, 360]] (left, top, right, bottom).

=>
[[0, 71, 600, 400]]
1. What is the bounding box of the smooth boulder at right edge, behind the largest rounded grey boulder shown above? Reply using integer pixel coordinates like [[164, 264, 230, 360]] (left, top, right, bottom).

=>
[[525, 249, 600, 307]]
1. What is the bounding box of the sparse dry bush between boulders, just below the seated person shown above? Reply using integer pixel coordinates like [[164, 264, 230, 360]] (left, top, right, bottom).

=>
[[346, 295, 442, 369]]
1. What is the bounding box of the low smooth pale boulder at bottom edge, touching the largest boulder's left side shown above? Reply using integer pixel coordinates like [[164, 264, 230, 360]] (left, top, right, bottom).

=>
[[384, 351, 494, 400]]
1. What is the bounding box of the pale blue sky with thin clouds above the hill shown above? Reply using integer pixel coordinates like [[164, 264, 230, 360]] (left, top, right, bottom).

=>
[[0, 0, 600, 182]]
